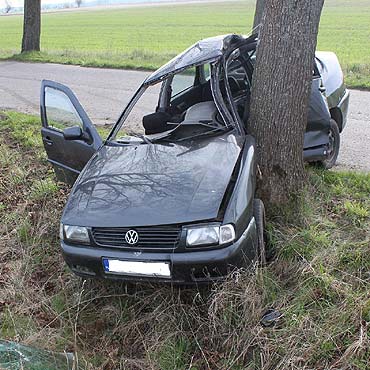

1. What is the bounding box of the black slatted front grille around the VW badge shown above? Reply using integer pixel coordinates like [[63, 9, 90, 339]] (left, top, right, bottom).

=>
[[91, 226, 181, 249]]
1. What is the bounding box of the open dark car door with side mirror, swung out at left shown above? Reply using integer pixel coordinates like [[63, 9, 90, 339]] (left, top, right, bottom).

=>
[[40, 80, 102, 184]]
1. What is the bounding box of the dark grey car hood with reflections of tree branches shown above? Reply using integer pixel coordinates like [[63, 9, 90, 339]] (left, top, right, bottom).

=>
[[62, 133, 242, 227]]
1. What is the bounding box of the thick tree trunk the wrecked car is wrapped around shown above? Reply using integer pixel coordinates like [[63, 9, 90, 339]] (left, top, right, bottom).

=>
[[249, 0, 324, 205]]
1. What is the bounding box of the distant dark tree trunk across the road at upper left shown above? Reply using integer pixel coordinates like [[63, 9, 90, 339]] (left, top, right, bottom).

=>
[[22, 0, 41, 53]]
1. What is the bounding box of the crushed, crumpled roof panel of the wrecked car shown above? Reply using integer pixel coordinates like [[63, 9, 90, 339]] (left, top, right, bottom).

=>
[[144, 34, 249, 85]]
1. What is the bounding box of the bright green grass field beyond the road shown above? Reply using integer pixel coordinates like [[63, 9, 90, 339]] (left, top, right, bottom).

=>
[[0, 0, 370, 89]]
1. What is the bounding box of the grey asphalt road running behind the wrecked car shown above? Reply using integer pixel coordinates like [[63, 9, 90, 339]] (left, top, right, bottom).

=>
[[0, 61, 370, 172]]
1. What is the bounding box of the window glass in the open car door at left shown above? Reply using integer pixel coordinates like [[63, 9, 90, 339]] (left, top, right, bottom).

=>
[[45, 87, 83, 131]]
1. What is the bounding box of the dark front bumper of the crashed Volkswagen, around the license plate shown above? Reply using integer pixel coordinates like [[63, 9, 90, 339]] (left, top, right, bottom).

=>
[[61, 218, 257, 284]]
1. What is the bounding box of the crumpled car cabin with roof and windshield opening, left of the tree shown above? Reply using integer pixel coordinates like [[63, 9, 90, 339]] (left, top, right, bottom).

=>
[[107, 35, 257, 144]]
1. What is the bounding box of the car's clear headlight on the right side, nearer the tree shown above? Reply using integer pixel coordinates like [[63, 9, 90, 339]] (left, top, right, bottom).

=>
[[186, 224, 235, 247]]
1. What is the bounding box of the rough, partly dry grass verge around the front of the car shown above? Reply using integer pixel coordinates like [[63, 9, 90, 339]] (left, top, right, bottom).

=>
[[0, 112, 370, 370]]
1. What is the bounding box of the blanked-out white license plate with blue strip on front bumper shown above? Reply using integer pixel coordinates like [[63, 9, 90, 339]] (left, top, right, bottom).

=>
[[103, 258, 171, 278]]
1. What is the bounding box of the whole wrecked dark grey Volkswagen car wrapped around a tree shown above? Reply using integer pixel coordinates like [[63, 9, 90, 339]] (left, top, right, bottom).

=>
[[41, 35, 348, 283]]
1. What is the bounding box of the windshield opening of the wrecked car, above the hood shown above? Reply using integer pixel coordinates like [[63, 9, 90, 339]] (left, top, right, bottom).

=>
[[109, 64, 228, 145]]
